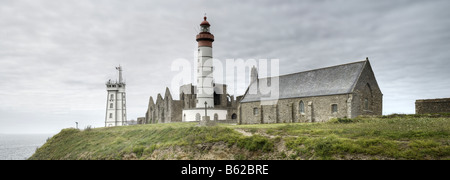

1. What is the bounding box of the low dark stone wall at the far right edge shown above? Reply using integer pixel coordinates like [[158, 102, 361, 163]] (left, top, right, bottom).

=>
[[416, 98, 450, 114]]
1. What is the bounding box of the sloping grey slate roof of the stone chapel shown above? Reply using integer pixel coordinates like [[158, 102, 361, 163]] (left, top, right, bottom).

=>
[[241, 60, 367, 102]]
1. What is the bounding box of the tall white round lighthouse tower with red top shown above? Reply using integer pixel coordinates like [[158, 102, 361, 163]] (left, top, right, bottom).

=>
[[196, 16, 214, 108]]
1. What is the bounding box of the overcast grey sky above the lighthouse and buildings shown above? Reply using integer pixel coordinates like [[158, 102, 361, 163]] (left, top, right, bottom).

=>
[[0, 0, 450, 133]]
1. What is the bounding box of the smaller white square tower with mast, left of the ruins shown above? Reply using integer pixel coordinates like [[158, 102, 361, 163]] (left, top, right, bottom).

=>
[[105, 65, 127, 127]]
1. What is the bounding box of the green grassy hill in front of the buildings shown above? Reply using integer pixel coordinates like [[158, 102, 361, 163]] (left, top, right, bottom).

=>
[[29, 115, 450, 159]]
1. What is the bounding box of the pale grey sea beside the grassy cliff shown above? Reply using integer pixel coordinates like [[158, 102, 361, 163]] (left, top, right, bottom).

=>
[[0, 134, 53, 160]]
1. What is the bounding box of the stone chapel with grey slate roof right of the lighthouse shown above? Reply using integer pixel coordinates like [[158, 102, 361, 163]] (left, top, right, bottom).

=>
[[238, 58, 383, 124]]
